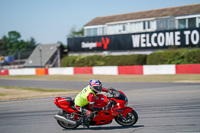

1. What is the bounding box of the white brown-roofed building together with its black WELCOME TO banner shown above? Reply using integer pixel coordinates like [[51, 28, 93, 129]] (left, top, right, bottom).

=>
[[68, 4, 200, 55]]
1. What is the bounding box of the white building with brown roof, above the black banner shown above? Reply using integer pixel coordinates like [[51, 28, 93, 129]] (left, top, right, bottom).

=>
[[84, 4, 200, 36]]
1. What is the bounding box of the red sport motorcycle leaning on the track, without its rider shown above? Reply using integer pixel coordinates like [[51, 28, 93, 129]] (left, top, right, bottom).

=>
[[54, 90, 138, 129]]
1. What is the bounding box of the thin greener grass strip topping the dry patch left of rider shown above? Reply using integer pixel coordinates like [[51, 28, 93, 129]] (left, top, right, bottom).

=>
[[0, 86, 73, 92]]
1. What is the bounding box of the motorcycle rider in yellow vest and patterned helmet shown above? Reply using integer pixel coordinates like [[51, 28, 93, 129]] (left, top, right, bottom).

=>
[[75, 79, 114, 128]]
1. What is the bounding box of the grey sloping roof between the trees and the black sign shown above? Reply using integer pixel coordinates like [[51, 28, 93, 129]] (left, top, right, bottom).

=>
[[24, 43, 61, 67]]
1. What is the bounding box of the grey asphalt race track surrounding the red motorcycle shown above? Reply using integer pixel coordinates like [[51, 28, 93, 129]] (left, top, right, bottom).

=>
[[0, 80, 200, 133]]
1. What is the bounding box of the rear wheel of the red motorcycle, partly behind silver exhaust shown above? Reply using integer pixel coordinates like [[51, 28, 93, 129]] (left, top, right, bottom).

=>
[[57, 110, 79, 129]]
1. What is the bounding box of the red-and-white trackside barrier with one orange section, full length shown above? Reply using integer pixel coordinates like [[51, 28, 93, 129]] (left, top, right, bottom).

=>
[[0, 64, 200, 75]]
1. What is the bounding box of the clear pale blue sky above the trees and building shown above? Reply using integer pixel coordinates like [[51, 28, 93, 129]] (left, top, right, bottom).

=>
[[0, 0, 200, 44]]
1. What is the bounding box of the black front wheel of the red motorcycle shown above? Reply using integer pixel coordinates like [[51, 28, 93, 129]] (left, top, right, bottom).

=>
[[115, 110, 138, 126]]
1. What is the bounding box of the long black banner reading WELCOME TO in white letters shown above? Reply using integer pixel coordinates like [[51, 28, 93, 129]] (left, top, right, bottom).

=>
[[68, 28, 200, 52]]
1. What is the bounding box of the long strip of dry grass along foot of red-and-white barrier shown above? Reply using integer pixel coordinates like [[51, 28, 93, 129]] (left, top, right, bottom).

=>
[[0, 74, 200, 82]]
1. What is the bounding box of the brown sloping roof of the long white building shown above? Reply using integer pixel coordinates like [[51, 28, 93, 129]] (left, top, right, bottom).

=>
[[85, 4, 200, 26]]
